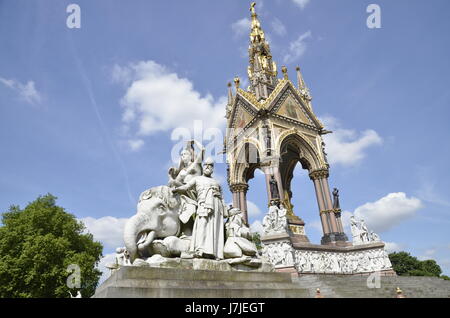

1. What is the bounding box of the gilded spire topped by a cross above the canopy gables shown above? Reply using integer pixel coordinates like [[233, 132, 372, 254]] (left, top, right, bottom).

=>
[[247, 2, 277, 101]]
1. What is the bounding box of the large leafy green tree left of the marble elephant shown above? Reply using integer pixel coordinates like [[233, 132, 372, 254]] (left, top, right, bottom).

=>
[[0, 194, 103, 298]]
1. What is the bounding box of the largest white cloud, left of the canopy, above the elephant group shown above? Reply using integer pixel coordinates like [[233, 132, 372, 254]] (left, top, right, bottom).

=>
[[112, 61, 226, 139]]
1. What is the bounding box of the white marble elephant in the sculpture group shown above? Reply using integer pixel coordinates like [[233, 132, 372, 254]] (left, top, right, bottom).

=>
[[123, 186, 189, 263]]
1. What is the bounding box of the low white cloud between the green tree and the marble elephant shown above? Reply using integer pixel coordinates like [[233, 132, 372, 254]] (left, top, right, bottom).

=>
[[80, 216, 128, 249]]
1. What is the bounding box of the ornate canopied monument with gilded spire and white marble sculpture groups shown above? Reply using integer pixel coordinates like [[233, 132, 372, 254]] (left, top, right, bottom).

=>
[[94, 3, 395, 297]]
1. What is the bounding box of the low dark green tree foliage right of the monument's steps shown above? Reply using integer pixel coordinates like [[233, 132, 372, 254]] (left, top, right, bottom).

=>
[[389, 252, 442, 277]]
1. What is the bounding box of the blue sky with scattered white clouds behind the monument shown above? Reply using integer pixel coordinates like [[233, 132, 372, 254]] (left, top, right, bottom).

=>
[[0, 0, 450, 275]]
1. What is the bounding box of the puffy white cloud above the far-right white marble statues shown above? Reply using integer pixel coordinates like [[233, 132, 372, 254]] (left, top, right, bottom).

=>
[[353, 192, 423, 233]]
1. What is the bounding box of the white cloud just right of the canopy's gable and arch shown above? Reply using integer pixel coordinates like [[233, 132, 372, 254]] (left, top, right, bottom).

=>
[[322, 117, 383, 166]]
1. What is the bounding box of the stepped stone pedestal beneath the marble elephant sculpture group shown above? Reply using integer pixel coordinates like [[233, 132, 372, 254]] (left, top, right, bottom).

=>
[[93, 260, 309, 298]]
